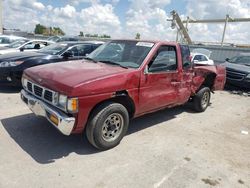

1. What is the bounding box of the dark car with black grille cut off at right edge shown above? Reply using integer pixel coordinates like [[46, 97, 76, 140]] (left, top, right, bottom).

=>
[[224, 53, 250, 89]]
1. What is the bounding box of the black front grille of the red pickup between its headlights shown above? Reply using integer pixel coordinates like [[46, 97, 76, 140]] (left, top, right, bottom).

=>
[[27, 81, 55, 103]]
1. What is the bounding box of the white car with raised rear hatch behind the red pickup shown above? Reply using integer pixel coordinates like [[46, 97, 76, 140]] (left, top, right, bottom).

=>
[[191, 48, 214, 65]]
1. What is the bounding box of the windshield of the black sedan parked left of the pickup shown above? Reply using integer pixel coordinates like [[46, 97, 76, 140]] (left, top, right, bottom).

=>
[[37, 43, 68, 55]]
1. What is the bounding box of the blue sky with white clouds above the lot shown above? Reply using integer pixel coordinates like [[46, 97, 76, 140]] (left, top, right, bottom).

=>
[[3, 0, 250, 44]]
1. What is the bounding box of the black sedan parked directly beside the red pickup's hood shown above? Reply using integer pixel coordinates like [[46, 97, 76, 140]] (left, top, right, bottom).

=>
[[0, 41, 103, 86]]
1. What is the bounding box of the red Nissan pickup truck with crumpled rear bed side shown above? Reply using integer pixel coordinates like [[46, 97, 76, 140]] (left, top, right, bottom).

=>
[[21, 40, 225, 150]]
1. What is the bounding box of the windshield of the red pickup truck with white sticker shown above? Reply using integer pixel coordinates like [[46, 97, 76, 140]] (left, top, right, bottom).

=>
[[88, 41, 154, 68]]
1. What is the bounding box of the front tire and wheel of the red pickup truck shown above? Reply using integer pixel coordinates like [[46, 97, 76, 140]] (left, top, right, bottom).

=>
[[86, 102, 129, 150]]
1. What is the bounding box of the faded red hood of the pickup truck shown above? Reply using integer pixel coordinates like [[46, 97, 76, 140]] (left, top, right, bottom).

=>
[[24, 60, 139, 96]]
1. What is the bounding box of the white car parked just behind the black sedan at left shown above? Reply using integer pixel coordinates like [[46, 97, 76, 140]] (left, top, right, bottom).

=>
[[0, 39, 54, 55]]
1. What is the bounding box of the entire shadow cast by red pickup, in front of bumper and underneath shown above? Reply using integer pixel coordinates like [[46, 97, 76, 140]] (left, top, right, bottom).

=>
[[1, 106, 192, 164]]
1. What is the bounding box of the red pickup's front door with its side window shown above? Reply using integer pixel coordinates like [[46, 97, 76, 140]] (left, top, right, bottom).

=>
[[139, 45, 179, 113]]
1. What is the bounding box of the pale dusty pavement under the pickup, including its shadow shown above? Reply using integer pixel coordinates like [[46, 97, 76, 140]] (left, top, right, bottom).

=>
[[0, 88, 250, 188]]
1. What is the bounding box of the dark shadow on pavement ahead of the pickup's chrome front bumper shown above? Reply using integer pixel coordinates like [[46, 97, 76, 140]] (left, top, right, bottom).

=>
[[1, 114, 98, 164]]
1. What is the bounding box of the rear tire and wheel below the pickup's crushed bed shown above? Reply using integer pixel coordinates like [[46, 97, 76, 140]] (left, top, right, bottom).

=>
[[193, 87, 211, 112]]
